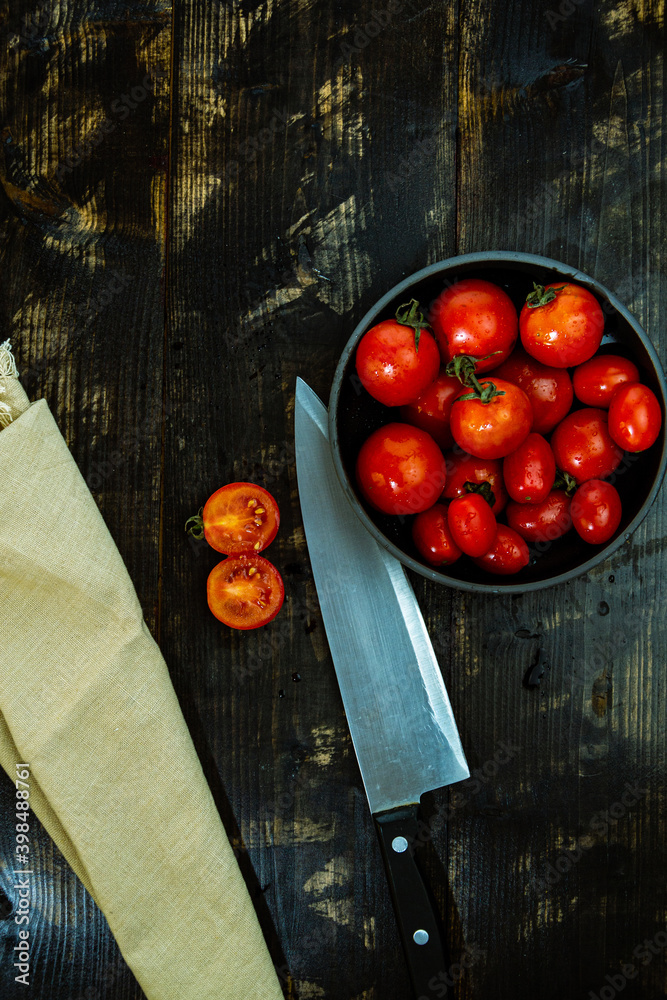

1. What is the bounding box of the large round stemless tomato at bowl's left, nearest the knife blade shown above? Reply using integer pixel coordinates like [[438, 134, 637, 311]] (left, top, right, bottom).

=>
[[357, 424, 447, 514]]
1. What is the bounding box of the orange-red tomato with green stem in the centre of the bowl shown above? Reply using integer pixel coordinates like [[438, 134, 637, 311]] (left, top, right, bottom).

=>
[[450, 378, 533, 458]]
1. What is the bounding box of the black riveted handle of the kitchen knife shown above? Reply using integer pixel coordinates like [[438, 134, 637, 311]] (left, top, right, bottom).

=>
[[373, 805, 451, 1000]]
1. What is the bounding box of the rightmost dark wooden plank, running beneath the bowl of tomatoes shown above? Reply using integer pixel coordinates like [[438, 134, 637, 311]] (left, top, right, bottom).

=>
[[451, 2, 666, 998]]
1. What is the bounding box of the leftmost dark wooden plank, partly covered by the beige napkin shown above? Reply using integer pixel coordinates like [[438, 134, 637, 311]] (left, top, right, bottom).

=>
[[0, 0, 171, 1000]]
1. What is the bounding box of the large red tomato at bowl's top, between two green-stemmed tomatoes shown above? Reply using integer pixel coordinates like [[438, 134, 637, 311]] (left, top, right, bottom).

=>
[[429, 278, 519, 375]]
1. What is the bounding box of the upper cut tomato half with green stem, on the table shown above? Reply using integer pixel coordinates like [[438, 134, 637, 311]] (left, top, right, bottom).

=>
[[185, 483, 280, 555]]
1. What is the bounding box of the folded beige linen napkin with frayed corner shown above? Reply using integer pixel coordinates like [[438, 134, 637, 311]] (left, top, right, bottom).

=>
[[0, 343, 282, 1000]]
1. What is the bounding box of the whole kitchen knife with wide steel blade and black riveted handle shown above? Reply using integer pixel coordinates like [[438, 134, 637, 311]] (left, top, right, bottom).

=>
[[295, 378, 470, 1000]]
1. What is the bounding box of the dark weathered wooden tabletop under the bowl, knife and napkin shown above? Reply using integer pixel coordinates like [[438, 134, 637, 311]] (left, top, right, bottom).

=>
[[0, 0, 667, 1000]]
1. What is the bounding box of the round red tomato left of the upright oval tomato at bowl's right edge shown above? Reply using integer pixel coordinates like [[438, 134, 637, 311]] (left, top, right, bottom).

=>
[[551, 408, 623, 483]]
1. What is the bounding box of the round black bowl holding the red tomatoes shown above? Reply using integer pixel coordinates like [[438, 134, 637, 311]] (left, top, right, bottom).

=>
[[329, 251, 667, 594]]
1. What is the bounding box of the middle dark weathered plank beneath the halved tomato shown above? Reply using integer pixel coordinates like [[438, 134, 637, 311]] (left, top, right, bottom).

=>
[[162, 2, 456, 1000]]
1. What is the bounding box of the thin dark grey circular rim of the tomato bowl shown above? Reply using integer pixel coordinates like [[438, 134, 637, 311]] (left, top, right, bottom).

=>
[[328, 250, 667, 594]]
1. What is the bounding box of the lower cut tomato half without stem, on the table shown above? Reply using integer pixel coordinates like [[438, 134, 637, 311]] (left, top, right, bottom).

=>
[[206, 555, 285, 629]]
